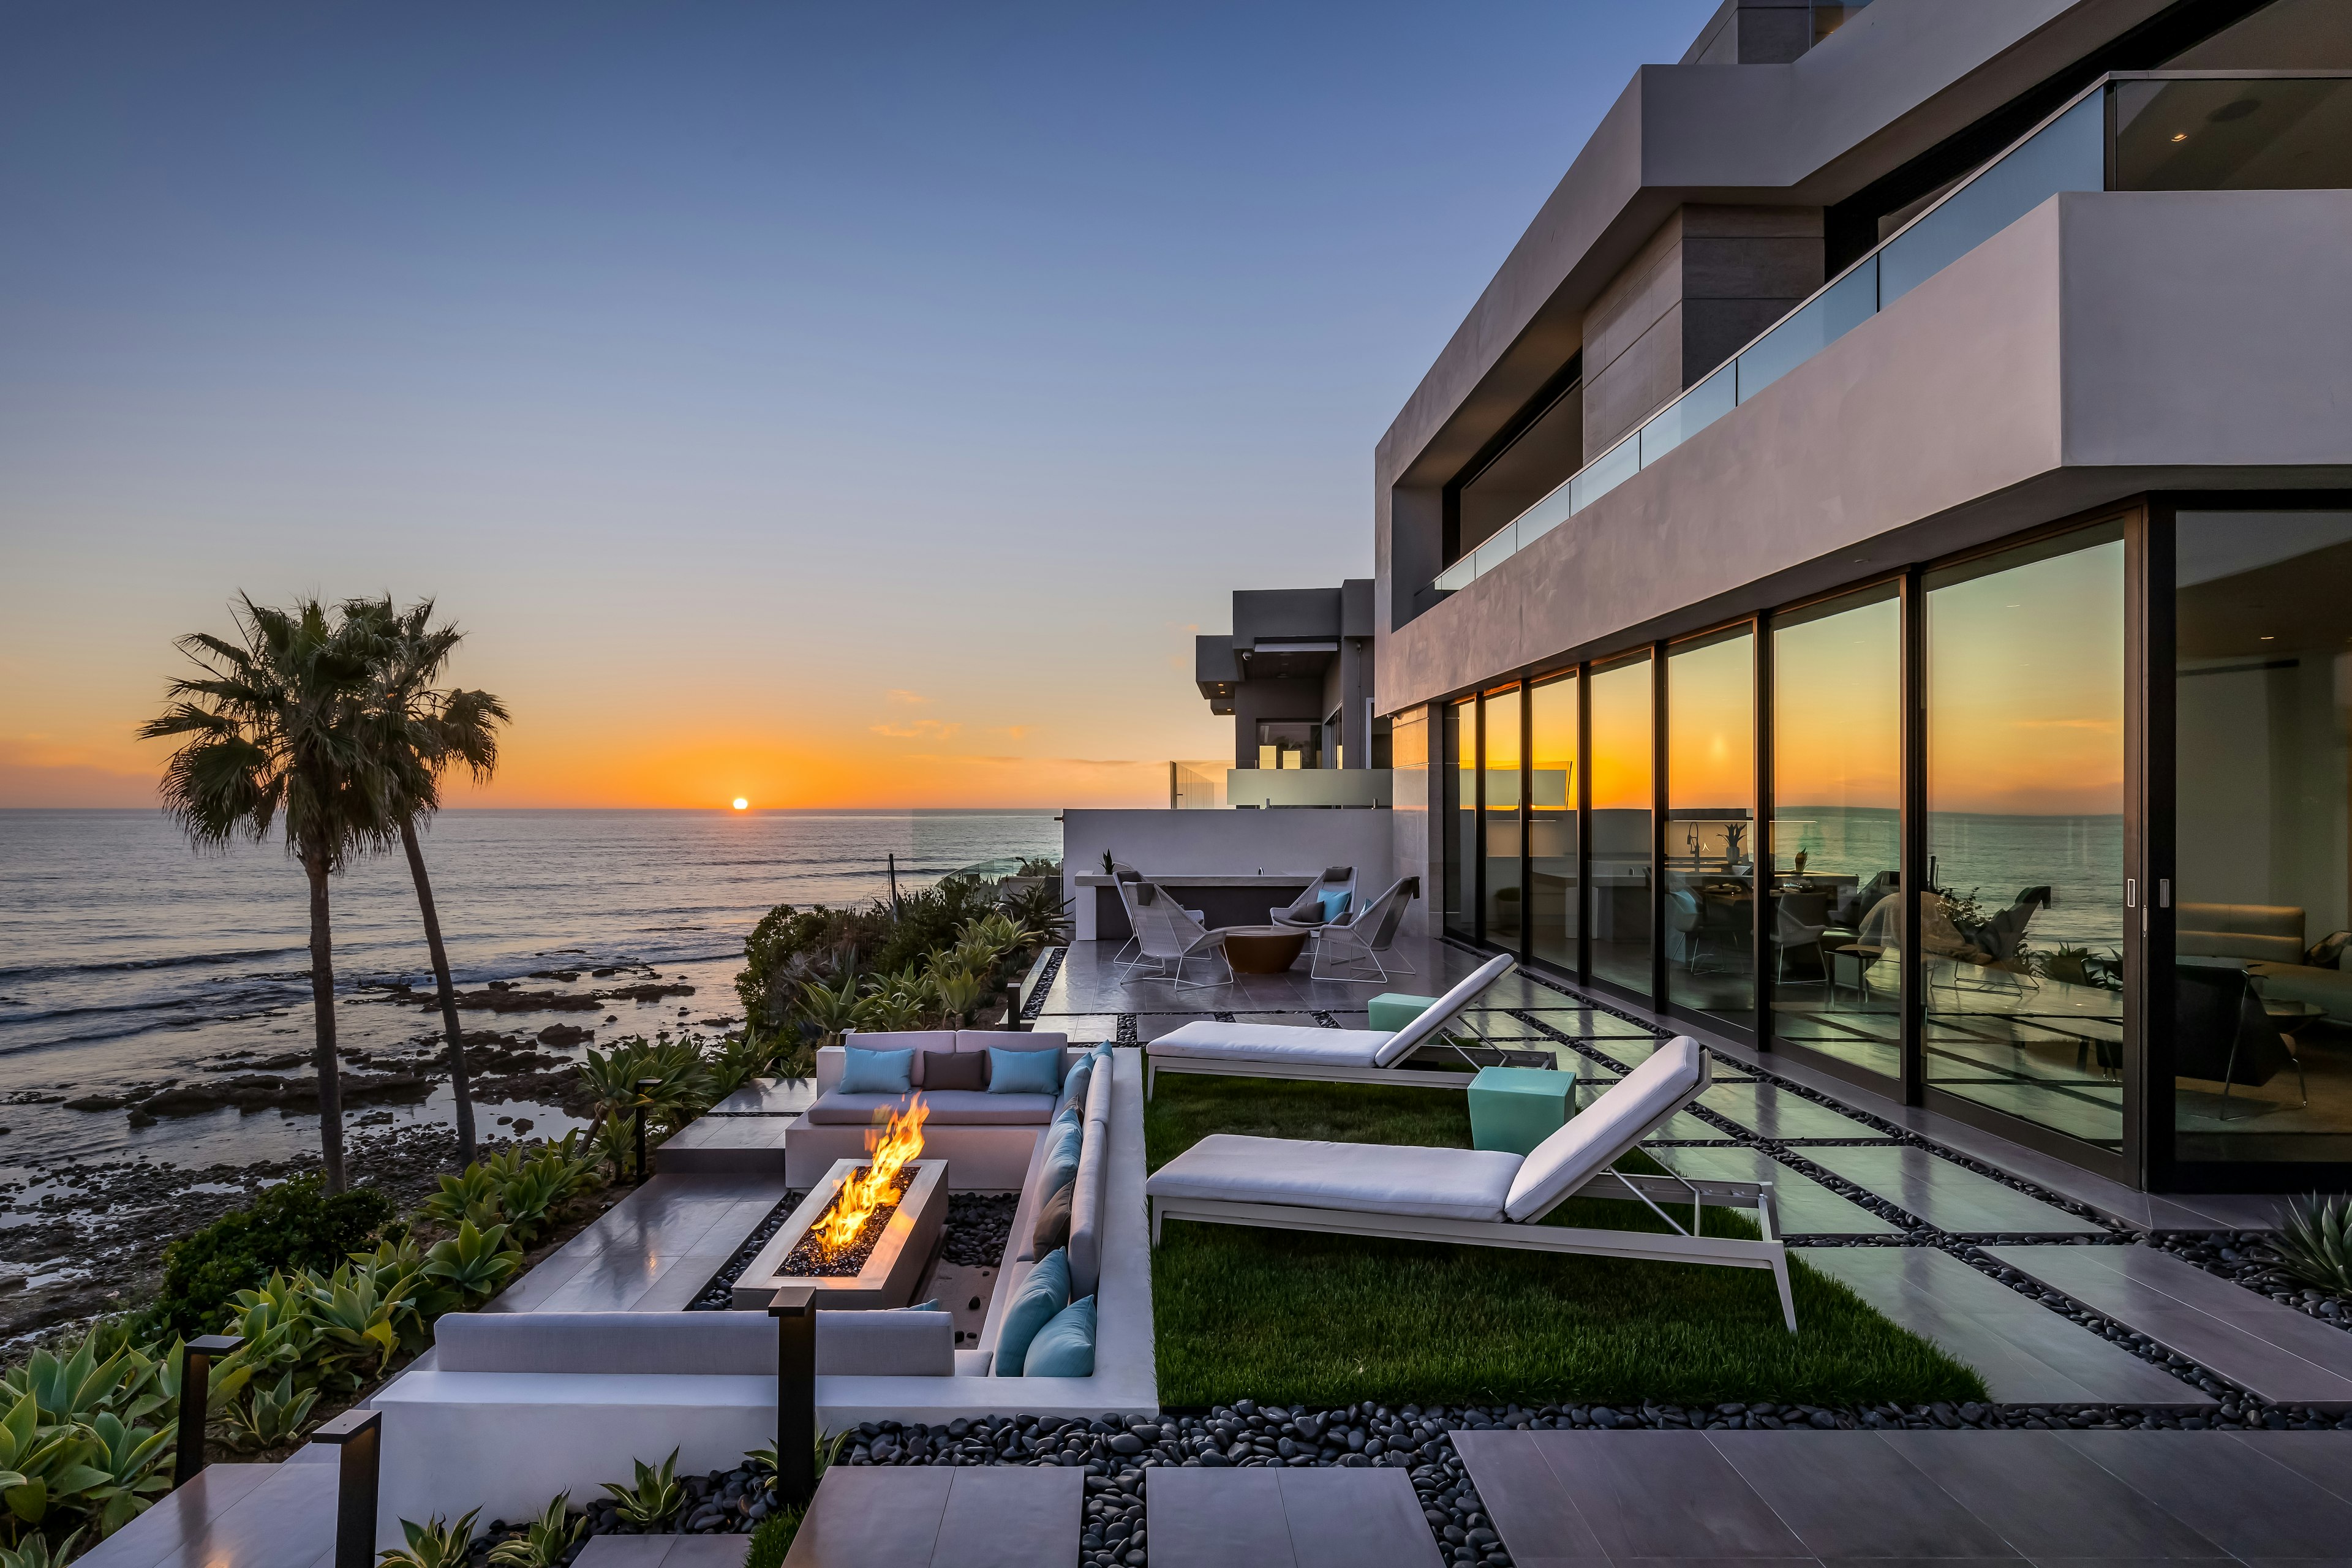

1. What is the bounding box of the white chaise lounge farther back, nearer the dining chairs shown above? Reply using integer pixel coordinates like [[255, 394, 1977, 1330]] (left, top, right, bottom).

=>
[[1143, 954, 1515, 1100]]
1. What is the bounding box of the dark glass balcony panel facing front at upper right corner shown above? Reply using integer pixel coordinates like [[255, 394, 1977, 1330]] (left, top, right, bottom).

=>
[[2114, 78, 2352, 190]]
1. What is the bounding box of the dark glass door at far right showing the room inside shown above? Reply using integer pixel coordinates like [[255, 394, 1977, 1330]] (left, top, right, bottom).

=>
[[2150, 513, 2352, 1161]]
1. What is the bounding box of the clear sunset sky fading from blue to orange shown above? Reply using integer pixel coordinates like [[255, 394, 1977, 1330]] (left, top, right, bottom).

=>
[[0, 0, 1714, 809]]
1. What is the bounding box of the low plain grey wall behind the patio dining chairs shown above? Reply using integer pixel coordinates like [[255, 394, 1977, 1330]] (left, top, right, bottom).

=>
[[1061, 806, 1395, 900]]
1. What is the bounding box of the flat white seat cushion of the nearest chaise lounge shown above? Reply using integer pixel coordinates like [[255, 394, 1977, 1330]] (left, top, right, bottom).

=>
[[1143, 1133, 1520, 1220]]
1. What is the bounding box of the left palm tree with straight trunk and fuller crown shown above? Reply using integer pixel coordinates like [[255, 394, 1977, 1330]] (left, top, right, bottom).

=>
[[139, 595, 393, 1192]]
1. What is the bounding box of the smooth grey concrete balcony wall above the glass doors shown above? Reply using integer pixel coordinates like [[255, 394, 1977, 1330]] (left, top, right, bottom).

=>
[[1378, 187, 2352, 712]]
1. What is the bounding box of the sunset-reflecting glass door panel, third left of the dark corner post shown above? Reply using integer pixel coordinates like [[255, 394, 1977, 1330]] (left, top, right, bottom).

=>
[[1658, 625, 1757, 1030]]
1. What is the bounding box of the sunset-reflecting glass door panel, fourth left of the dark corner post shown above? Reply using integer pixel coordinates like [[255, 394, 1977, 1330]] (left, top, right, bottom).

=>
[[1585, 654, 1658, 997]]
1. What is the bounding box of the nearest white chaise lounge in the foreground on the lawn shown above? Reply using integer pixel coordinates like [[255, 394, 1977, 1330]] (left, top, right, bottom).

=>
[[1143, 1035, 1797, 1333]]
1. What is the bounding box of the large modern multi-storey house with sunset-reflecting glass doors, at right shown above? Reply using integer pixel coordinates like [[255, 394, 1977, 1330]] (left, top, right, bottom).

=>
[[1373, 0, 2352, 1192]]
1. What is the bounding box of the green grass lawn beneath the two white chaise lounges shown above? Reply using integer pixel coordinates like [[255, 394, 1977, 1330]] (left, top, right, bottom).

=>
[[1143, 1074, 1985, 1408]]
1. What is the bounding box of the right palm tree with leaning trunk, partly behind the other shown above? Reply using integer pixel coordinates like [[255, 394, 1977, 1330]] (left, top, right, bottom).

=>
[[344, 595, 508, 1166]]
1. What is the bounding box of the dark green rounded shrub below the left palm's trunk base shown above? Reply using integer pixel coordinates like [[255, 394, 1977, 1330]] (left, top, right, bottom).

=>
[[151, 1175, 393, 1338]]
